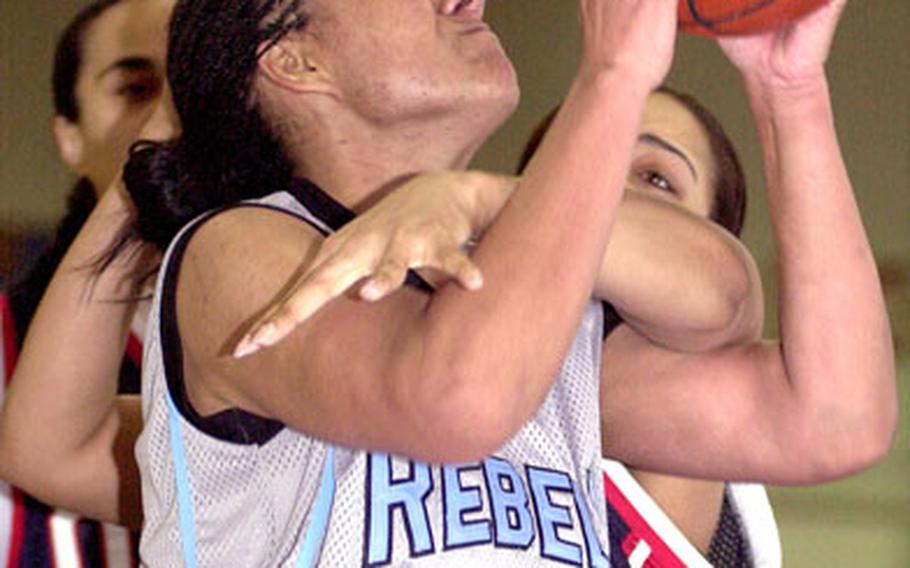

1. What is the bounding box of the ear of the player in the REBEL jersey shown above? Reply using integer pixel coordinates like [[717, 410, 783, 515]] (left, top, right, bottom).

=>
[[259, 36, 334, 93]]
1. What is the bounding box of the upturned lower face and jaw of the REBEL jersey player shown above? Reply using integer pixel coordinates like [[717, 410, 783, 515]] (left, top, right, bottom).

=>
[[304, 0, 518, 127]]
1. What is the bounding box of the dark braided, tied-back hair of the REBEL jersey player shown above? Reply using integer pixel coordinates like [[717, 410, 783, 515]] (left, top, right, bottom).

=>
[[124, 0, 307, 250]]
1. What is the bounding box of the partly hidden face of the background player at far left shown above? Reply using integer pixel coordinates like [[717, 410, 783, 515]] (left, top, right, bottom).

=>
[[55, 0, 177, 192]]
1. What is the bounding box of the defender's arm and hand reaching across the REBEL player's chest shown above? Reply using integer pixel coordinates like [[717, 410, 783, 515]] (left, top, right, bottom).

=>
[[256, 171, 763, 351]]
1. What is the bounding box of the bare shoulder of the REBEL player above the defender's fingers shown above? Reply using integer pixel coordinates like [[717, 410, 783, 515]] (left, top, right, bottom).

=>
[[159, 205, 323, 411]]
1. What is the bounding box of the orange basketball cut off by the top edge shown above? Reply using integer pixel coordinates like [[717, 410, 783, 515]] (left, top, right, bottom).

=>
[[679, 0, 828, 37]]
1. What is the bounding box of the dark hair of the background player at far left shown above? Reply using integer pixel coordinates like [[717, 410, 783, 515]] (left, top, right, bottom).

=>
[[9, 0, 123, 338]]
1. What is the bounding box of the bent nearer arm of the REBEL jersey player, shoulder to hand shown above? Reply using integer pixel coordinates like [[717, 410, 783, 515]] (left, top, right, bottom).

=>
[[187, 0, 675, 461]]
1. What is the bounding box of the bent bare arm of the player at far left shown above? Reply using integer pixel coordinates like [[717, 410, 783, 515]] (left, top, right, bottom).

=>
[[0, 183, 143, 526]]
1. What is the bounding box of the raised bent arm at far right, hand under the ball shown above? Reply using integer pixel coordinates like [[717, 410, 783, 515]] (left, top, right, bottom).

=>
[[603, 0, 897, 484]]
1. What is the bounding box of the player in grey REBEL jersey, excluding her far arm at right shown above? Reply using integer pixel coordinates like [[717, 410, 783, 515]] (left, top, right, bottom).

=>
[[80, 0, 712, 565]]
